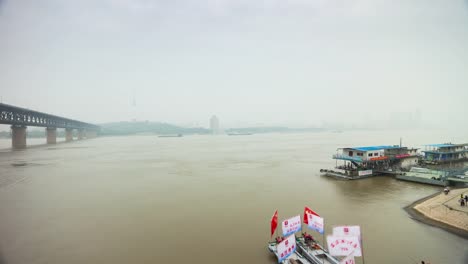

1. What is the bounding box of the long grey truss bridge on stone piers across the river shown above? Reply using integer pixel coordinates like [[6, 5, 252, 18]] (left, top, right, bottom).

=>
[[0, 103, 100, 149]]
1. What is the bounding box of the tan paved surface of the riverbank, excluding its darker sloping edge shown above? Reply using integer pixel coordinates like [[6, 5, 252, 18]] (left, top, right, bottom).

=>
[[414, 188, 468, 231]]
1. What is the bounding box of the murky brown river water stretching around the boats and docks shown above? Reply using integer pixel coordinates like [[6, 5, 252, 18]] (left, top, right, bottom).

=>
[[0, 131, 468, 264]]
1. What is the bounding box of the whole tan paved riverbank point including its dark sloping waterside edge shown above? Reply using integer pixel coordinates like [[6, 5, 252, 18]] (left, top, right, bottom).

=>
[[404, 188, 468, 239]]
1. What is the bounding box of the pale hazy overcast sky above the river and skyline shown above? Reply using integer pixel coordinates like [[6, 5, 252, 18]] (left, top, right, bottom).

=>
[[0, 0, 468, 126]]
